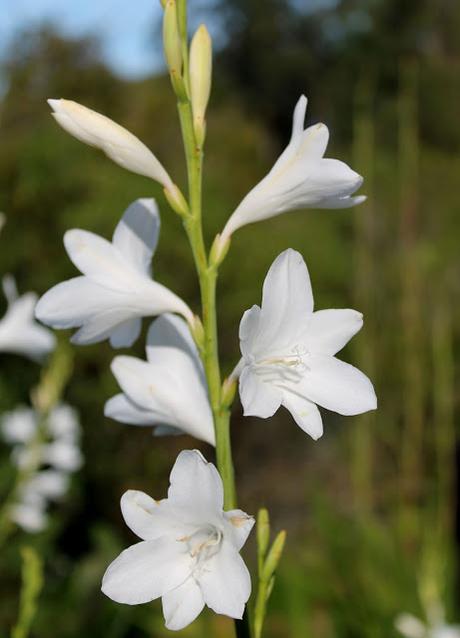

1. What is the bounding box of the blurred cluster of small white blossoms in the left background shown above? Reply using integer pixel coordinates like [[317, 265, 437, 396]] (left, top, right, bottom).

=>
[[0, 404, 83, 533]]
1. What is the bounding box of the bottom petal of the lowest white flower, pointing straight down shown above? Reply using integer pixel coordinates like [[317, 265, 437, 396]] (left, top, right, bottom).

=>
[[162, 576, 204, 631]]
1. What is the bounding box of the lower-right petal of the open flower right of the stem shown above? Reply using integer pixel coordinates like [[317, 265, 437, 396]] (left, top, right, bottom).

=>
[[302, 354, 377, 416]]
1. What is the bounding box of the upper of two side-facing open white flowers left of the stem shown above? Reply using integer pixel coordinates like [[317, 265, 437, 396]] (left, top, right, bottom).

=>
[[36, 199, 192, 348]]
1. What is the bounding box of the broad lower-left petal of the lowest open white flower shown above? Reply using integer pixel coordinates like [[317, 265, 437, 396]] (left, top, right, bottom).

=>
[[102, 536, 192, 605]]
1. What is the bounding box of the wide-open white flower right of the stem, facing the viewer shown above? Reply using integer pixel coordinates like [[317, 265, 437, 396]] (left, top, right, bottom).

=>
[[238, 249, 377, 439]]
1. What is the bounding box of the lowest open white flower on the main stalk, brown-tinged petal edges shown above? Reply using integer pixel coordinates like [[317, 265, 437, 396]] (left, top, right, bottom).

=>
[[102, 450, 254, 630]]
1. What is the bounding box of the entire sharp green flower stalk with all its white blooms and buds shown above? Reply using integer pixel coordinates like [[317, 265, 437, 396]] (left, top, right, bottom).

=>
[[37, 0, 377, 638]]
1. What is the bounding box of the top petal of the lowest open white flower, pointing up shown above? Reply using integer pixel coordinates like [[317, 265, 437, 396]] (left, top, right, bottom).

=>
[[168, 450, 224, 522]]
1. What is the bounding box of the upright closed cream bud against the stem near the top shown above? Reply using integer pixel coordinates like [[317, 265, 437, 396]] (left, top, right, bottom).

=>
[[190, 24, 212, 146]]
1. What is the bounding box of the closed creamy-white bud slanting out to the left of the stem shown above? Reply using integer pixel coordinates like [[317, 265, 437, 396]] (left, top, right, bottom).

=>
[[48, 100, 174, 190]]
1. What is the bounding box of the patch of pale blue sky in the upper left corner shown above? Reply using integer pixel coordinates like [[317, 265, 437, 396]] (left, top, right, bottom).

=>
[[0, 0, 167, 77]]
